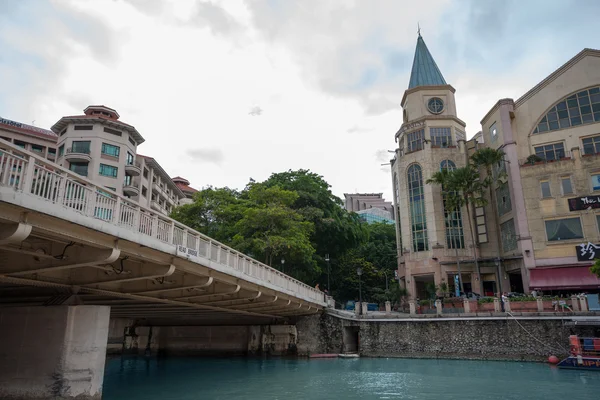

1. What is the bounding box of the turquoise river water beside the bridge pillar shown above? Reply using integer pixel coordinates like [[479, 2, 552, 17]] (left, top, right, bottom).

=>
[[103, 358, 600, 400]]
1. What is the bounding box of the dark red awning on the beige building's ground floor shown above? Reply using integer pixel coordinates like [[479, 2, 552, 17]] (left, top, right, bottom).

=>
[[529, 266, 600, 290]]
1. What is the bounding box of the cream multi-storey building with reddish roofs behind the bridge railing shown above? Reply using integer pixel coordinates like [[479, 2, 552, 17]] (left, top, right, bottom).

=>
[[0, 105, 195, 214]]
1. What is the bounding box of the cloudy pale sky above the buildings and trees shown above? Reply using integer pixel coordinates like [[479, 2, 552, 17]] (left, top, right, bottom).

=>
[[0, 0, 600, 200]]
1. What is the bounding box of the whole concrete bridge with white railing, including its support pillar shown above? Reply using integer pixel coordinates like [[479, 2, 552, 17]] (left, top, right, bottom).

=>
[[0, 139, 326, 398]]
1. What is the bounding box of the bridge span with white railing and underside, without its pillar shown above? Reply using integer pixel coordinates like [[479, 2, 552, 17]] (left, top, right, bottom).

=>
[[0, 139, 326, 324]]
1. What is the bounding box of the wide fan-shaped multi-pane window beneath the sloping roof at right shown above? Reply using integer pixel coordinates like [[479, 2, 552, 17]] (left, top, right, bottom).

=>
[[533, 86, 600, 134]]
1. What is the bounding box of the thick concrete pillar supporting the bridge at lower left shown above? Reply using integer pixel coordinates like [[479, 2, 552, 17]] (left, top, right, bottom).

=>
[[0, 305, 110, 400]]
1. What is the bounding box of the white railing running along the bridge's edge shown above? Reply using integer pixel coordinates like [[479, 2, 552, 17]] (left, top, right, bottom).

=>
[[0, 139, 325, 305]]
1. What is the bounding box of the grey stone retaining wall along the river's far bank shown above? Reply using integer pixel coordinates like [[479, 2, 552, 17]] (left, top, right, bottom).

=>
[[296, 314, 600, 360]]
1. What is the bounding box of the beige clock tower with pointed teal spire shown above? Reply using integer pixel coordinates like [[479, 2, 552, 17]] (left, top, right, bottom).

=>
[[391, 33, 476, 298]]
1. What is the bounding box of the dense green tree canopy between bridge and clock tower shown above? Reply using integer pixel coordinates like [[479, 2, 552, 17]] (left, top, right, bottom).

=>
[[171, 170, 398, 301]]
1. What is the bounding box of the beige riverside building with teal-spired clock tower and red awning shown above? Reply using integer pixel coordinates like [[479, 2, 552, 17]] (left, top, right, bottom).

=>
[[391, 35, 600, 297]]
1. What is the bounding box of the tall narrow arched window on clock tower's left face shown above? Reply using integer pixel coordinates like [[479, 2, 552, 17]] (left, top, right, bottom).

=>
[[407, 164, 429, 251]]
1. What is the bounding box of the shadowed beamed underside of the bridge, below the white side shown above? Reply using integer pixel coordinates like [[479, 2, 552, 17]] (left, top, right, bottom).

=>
[[0, 203, 321, 325]]
